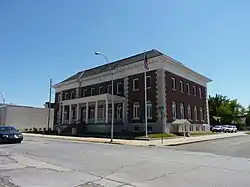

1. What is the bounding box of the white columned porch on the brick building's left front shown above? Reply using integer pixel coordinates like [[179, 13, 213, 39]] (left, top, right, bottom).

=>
[[58, 94, 125, 124]]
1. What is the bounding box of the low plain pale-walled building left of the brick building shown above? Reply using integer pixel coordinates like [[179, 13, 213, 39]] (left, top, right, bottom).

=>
[[0, 104, 54, 130]]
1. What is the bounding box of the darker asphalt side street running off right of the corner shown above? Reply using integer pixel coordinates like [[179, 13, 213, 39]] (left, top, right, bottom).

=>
[[171, 135, 250, 158]]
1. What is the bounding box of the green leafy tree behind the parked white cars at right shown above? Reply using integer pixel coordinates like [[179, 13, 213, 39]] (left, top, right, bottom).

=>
[[208, 94, 246, 125]]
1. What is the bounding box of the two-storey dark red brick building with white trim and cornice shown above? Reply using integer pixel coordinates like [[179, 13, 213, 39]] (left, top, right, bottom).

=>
[[54, 49, 211, 132]]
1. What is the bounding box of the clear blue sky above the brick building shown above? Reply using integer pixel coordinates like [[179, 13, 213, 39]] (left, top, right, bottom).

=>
[[0, 0, 250, 106]]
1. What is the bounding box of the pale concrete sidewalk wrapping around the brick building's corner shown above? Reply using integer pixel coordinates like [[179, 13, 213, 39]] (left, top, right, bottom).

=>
[[23, 132, 246, 146]]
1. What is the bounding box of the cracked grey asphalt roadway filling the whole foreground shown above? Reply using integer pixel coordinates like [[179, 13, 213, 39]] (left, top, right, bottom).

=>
[[0, 136, 250, 187]]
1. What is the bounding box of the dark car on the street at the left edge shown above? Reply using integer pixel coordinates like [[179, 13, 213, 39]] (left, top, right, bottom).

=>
[[0, 126, 23, 143]]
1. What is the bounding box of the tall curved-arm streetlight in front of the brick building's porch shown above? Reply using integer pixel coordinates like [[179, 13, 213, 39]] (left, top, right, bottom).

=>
[[95, 52, 114, 142]]
